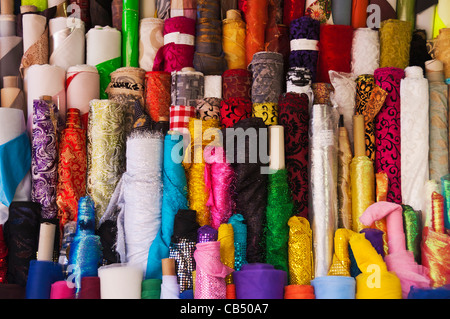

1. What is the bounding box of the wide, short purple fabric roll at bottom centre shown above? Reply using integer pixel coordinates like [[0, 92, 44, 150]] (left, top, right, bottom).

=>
[[233, 263, 288, 299]]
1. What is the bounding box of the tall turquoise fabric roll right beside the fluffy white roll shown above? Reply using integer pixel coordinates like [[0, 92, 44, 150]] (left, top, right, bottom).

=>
[[145, 133, 188, 279]]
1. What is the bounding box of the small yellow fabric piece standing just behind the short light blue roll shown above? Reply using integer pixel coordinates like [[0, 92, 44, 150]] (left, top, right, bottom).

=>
[[328, 228, 357, 276]]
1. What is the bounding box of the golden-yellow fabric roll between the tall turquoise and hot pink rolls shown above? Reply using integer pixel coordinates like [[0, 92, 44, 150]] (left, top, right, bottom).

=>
[[183, 118, 220, 226]]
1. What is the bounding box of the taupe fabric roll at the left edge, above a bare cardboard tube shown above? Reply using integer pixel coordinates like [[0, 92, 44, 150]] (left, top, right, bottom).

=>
[[0, 36, 23, 89]]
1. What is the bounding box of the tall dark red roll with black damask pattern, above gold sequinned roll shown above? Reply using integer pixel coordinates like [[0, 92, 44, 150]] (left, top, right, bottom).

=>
[[278, 93, 309, 217]]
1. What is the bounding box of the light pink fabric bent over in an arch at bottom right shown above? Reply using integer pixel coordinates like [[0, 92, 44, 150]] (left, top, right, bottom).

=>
[[359, 201, 431, 298]]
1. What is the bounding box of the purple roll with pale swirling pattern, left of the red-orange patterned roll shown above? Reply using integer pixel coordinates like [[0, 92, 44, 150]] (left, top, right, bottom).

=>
[[31, 100, 58, 219]]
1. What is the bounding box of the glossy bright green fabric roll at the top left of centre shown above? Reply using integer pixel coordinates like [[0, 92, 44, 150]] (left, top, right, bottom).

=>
[[122, 0, 139, 68]]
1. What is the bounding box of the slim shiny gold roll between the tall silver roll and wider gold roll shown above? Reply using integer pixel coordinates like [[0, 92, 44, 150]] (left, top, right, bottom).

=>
[[337, 127, 353, 229]]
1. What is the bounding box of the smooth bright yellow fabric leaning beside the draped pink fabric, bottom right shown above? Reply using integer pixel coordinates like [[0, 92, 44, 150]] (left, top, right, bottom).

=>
[[349, 234, 402, 299]]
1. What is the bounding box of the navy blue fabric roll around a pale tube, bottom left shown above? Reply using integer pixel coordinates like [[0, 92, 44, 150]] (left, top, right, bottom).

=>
[[25, 260, 64, 299]]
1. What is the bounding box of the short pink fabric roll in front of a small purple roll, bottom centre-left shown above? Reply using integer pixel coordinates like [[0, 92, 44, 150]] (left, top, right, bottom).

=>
[[194, 241, 233, 299]]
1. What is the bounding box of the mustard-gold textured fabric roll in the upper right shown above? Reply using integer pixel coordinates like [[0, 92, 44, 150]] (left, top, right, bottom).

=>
[[379, 19, 412, 69]]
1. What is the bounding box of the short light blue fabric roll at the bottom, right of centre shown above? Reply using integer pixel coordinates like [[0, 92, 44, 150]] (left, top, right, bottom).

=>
[[311, 276, 356, 299]]
